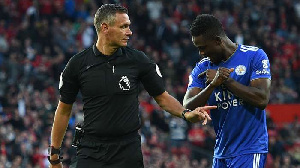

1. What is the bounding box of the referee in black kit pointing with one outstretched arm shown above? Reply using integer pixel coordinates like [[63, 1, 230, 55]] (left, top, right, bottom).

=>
[[48, 4, 216, 168]]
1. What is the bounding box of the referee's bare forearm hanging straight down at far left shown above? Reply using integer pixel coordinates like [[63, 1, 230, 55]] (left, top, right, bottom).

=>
[[50, 101, 73, 160]]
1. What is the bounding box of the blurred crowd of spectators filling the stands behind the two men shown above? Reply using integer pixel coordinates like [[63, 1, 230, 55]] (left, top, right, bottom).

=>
[[0, 0, 300, 168]]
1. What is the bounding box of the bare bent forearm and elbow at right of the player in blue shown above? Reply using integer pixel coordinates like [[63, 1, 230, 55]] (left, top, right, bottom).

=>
[[224, 78, 271, 109]]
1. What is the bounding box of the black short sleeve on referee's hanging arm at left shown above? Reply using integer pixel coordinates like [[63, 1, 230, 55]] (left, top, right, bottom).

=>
[[59, 58, 79, 104]]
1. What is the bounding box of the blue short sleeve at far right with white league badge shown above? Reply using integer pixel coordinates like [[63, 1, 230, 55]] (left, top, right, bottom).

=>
[[251, 49, 271, 80]]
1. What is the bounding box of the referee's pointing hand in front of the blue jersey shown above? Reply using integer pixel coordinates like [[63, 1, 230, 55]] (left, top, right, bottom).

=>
[[185, 106, 217, 125]]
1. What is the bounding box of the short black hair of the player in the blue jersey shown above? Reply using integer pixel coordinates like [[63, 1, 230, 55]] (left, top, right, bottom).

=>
[[190, 14, 225, 37]]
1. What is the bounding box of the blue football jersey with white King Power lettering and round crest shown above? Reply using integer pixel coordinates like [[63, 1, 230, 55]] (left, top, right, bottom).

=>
[[188, 45, 271, 158]]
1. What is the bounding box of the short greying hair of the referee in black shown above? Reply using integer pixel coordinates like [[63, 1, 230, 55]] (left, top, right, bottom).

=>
[[94, 4, 128, 32]]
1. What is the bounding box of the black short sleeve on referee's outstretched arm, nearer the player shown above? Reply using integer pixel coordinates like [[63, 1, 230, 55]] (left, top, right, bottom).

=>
[[139, 54, 165, 97]]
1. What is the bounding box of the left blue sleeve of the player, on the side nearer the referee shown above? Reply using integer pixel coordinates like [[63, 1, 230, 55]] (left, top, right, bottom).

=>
[[188, 60, 209, 89]]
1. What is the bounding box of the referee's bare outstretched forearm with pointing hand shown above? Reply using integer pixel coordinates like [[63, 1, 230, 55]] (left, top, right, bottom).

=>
[[154, 92, 217, 124]]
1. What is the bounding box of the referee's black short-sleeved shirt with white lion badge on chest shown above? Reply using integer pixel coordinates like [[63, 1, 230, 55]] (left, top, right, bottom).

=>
[[59, 45, 165, 138]]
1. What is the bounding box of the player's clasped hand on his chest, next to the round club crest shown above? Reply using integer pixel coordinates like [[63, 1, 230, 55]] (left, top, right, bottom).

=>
[[206, 67, 234, 86]]
